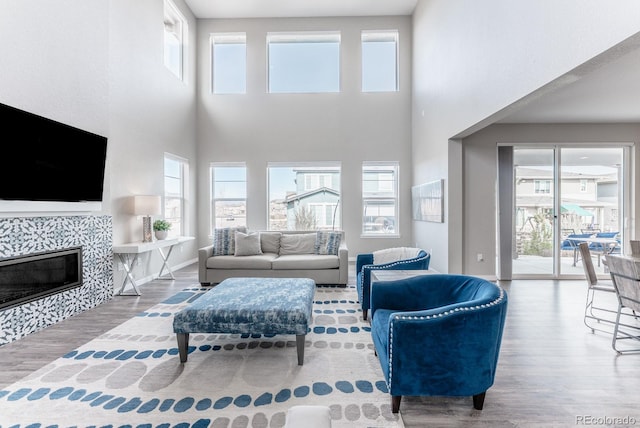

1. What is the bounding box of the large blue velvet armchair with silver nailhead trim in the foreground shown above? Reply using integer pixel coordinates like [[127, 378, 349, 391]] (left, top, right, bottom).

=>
[[371, 274, 507, 413]]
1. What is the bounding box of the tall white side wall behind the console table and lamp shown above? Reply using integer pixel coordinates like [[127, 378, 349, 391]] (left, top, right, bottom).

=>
[[108, 0, 197, 287]]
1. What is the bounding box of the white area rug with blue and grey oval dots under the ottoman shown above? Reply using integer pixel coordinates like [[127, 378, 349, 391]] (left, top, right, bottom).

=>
[[0, 286, 404, 428]]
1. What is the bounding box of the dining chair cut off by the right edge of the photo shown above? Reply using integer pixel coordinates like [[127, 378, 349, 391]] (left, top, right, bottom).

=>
[[607, 254, 640, 354]]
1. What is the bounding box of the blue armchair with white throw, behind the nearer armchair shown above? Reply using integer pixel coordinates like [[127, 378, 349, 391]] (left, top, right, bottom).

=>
[[356, 250, 431, 320]]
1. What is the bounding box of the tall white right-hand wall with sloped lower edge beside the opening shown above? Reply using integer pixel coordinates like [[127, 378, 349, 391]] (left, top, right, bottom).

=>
[[412, 0, 640, 272]]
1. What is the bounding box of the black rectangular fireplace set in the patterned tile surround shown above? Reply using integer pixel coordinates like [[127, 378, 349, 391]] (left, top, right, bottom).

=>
[[0, 247, 82, 310]]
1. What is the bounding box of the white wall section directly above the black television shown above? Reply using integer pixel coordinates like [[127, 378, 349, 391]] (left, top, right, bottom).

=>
[[0, 0, 109, 135]]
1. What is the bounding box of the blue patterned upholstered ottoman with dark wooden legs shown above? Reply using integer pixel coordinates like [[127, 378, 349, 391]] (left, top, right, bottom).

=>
[[173, 278, 316, 365]]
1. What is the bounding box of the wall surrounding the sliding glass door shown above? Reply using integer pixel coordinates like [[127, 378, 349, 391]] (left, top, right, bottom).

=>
[[461, 124, 640, 275]]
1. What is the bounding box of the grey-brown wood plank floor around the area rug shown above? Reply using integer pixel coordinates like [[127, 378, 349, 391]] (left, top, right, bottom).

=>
[[0, 265, 640, 428]]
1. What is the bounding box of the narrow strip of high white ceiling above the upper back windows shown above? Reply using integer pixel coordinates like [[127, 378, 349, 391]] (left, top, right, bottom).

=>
[[185, 0, 418, 18]]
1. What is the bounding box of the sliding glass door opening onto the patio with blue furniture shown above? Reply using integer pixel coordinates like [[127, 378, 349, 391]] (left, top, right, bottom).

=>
[[512, 145, 626, 278]]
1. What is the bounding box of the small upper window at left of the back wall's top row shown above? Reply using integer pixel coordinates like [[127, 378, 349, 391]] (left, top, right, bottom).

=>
[[211, 33, 247, 94]]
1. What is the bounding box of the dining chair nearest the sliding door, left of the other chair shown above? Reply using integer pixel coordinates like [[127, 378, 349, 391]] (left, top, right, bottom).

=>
[[578, 242, 617, 333]]
